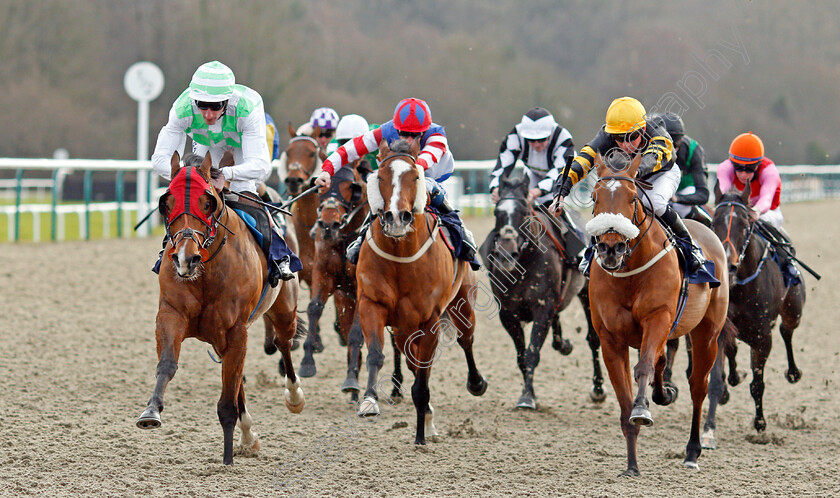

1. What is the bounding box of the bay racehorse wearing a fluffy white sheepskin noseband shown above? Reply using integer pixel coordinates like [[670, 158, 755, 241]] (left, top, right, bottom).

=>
[[586, 155, 729, 476]]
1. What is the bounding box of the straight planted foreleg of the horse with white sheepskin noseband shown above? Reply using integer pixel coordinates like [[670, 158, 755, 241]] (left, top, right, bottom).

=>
[[601, 341, 639, 476]]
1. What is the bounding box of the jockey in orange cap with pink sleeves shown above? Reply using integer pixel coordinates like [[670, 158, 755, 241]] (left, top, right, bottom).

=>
[[717, 132, 801, 284]]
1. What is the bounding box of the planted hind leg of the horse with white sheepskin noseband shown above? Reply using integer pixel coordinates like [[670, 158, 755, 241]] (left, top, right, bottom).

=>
[[683, 324, 718, 469]]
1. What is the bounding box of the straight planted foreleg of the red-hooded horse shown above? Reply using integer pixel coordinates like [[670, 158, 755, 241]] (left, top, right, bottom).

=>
[[216, 326, 248, 465]]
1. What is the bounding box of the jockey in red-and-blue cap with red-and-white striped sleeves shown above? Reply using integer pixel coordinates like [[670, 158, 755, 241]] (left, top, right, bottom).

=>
[[315, 98, 476, 264]]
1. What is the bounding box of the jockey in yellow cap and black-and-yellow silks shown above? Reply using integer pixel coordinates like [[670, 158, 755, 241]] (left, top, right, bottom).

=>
[[552, 97, 706, 274]]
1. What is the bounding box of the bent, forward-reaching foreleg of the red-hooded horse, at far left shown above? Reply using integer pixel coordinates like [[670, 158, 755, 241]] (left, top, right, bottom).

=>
[[137, 312, 186, 429]]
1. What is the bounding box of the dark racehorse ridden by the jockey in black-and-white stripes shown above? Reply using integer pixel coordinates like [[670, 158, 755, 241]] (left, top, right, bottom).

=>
[[481, 177, 606, 410]]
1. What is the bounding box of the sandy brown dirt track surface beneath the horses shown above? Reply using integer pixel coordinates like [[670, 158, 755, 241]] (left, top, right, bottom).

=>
[[0, 201, 840, 496]]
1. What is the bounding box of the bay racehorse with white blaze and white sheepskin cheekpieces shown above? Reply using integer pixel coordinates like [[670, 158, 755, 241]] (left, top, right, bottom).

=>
[[356, 140, 487, 445]]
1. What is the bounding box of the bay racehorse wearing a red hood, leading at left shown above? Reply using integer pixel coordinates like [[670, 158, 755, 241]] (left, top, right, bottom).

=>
[[137, 152, 304, 465]]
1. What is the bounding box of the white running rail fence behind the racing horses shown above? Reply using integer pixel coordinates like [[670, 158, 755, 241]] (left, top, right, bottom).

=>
[[0, 158, 840, 241]]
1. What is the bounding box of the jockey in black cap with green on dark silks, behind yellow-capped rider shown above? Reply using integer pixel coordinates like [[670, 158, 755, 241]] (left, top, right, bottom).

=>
[[660, 112, 712, 226]]
